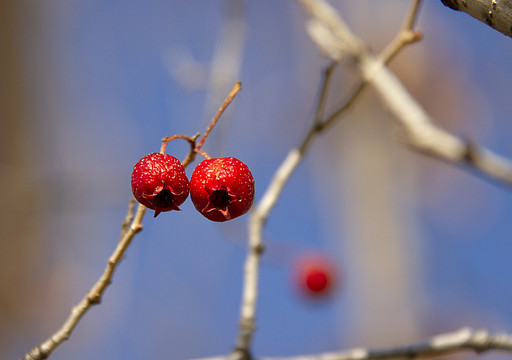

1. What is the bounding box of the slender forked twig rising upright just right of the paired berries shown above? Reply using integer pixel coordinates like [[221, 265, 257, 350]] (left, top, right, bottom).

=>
[[235, 0, 421, 359]]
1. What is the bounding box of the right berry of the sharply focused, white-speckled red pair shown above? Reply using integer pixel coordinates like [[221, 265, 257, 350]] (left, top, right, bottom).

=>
[[190, 157, 254, 222]]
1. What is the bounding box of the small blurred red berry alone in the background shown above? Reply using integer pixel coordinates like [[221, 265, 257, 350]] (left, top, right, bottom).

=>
[[295, 254, 336, 298]]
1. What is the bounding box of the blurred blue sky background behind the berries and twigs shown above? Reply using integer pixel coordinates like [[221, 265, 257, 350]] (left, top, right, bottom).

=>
[[3, 0, 512, 360]]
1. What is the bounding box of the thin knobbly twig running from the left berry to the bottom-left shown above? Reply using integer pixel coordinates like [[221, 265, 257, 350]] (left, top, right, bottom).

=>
[[22, 202, 146, 360]]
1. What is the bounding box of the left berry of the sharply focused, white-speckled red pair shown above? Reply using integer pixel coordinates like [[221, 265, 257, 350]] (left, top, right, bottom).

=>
[[132, 153, 189, 217]]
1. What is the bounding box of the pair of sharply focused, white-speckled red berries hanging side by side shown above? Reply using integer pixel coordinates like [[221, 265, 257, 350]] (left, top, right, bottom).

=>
[[131, 153, 254, 222]]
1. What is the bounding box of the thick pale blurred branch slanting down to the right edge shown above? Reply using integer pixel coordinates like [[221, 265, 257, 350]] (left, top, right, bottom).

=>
[[300, 0, 512, 185]]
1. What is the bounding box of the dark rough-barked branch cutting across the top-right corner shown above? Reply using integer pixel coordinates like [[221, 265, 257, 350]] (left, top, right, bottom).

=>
[[441, 0, 512, 37]]
